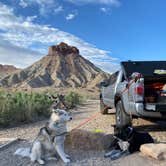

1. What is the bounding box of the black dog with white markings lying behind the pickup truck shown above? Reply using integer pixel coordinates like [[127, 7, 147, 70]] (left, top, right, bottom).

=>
[[104, 126, 154, 159]]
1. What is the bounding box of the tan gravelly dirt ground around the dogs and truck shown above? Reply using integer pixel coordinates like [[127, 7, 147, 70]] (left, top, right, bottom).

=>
[[0, 100, 166, 166]]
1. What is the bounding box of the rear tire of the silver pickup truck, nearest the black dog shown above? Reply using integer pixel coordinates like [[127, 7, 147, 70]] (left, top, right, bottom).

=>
[[115, 101, 132, 128]]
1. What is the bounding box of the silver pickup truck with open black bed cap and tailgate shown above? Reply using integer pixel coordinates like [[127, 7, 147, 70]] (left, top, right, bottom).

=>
[[100, 61, 166, 127]]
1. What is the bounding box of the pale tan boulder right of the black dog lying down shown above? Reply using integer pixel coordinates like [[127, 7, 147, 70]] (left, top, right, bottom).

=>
[[140, 143, 166, 160]]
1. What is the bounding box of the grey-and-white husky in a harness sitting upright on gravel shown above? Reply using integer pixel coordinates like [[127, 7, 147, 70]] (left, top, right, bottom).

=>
[[15, 108, 72, 164]]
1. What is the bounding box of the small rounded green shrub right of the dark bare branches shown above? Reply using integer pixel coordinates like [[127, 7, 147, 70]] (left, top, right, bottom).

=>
[[65, 91, 83, 108]]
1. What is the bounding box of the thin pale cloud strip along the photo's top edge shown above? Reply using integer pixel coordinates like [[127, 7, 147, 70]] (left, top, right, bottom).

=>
[[66, 0, 120, 6]]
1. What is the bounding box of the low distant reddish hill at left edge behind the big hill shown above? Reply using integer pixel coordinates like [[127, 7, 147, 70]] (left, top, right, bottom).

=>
[[0, 64, 19, 79]]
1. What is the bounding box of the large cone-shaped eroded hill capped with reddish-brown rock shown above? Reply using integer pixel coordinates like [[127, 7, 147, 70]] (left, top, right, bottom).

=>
[[1, 43, 108, 88]]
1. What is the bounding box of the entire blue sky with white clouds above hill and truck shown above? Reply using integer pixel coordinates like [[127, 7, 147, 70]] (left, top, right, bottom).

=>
[[0, 0, 166, 72]]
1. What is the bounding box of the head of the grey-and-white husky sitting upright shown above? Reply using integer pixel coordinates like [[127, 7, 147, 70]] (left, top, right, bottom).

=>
[[52, 109, 72, 122]]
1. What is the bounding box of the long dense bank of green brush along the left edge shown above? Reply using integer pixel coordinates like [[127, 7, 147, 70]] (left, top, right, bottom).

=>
[[0, 91, 51, 126]]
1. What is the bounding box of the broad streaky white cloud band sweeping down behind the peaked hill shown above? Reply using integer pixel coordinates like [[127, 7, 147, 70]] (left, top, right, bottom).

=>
[[0, 3, 117, 71]]
